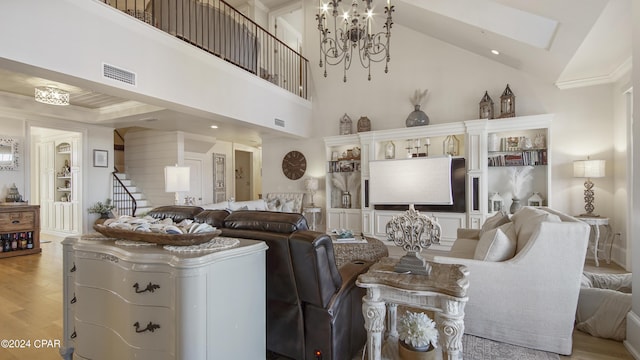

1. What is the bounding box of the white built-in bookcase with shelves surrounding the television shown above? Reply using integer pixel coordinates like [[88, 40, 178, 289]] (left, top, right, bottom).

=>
[[324, 114, 553, 250]]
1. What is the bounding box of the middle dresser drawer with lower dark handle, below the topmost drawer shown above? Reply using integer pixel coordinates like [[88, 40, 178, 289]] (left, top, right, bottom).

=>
[[75, 286, 175, 352]]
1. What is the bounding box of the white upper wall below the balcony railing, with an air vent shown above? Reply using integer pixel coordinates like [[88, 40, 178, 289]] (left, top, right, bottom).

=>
[[0, 0, 311, 136]]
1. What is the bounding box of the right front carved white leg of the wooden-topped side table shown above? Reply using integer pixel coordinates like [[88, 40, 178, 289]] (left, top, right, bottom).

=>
[[435, 300, 465, 360]]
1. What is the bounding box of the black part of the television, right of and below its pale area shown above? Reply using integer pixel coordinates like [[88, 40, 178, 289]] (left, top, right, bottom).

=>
[[365, 158, 467, 213]]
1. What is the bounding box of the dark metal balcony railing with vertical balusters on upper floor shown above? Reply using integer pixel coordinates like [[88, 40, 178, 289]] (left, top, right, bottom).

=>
[[102, 0, 308, 99]]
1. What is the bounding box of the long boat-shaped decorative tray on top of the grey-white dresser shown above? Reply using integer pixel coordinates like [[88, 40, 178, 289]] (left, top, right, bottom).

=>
[[93, 224, 222, 246]]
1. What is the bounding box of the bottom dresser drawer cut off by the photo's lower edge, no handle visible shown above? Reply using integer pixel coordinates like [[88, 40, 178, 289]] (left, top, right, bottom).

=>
[[73, 321, 175, 360]]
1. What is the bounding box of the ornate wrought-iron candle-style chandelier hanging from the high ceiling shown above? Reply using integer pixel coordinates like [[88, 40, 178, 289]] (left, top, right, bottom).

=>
[[316, 0, 394, 82]]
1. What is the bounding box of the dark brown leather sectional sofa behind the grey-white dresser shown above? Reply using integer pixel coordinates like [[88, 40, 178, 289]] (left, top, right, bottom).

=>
[[148, 205, 371, 360]]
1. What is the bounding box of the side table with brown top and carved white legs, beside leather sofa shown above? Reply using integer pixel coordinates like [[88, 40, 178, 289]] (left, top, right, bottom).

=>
[[356, 258, 469, 360]]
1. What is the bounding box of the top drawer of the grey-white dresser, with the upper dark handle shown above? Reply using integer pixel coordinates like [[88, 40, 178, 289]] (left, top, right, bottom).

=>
[[75, 257, 175, 307]]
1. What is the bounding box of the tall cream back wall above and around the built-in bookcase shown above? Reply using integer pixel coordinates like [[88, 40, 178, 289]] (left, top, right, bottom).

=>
[[263, 7, 617, 242]]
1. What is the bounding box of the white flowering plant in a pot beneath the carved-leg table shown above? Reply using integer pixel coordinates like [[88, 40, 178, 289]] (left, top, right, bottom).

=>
[[398, 311, 438, 360]]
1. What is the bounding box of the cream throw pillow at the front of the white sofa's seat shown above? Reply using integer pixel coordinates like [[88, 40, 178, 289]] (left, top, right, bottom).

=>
[[473, 223, 516, 261]]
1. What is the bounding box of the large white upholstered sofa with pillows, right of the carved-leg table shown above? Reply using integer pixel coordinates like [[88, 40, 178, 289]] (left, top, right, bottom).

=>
[[424, 207, 589, 355]]
